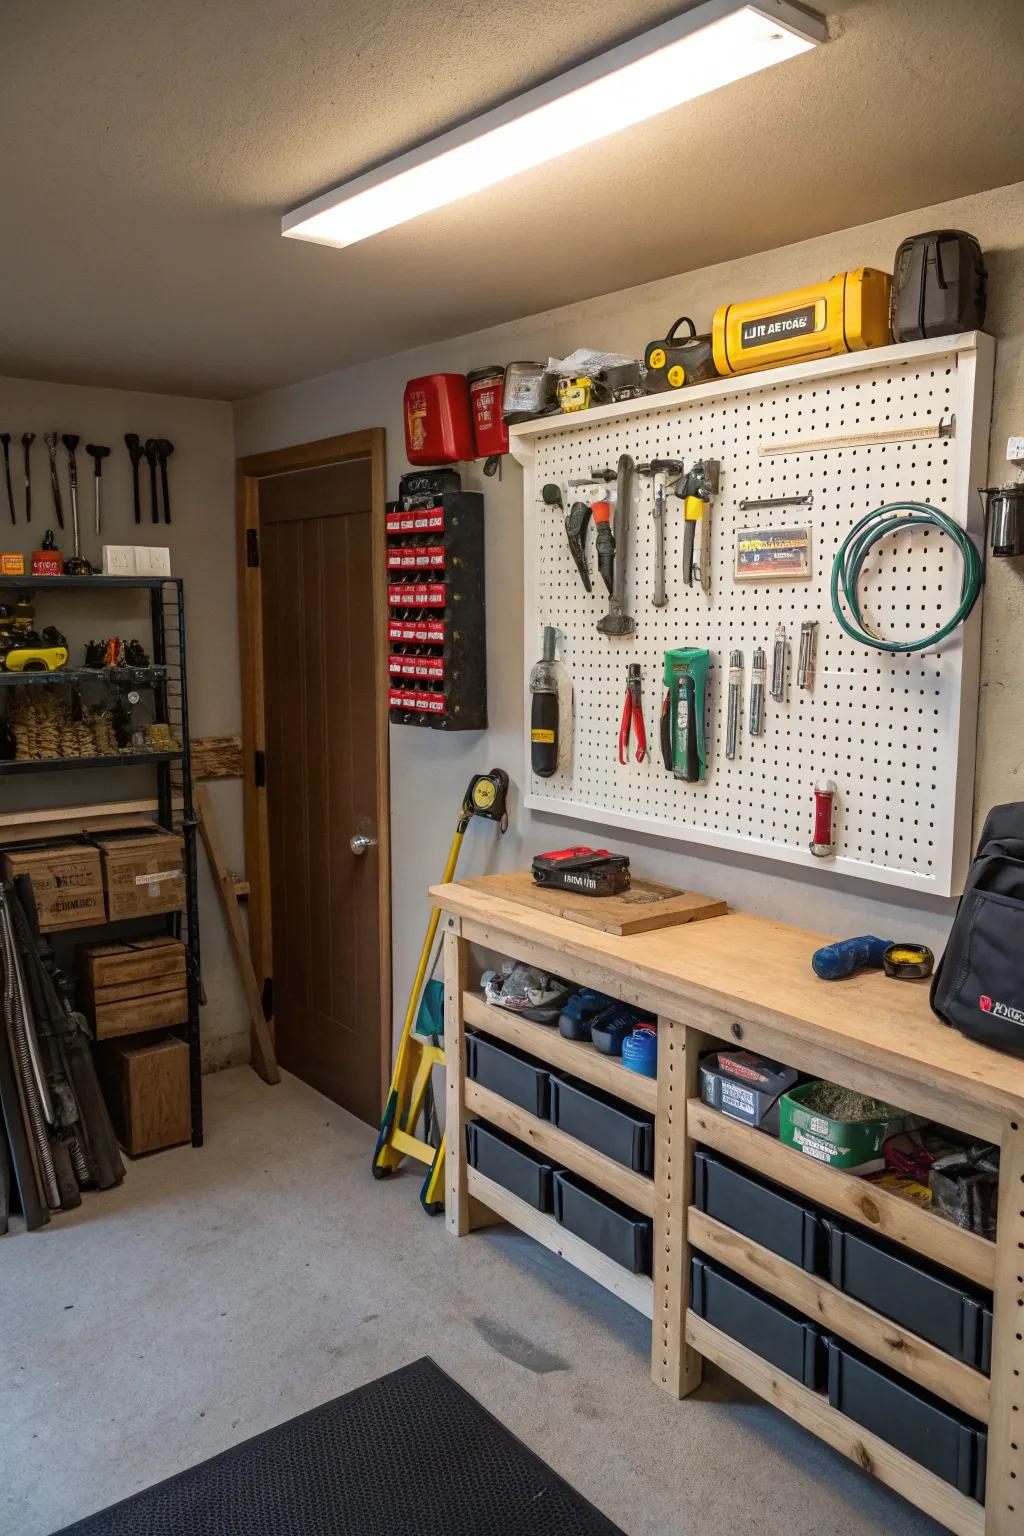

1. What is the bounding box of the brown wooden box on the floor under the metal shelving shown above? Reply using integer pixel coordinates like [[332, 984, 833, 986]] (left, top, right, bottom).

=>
[[100, 1035, 192, 1157]]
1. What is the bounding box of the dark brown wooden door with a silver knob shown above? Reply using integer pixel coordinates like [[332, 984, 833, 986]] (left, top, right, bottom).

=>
[[258, 458, 383, 1124]]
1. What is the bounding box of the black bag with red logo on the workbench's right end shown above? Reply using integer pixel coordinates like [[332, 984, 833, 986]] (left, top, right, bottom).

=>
[[932, 802, 1024, 1055]]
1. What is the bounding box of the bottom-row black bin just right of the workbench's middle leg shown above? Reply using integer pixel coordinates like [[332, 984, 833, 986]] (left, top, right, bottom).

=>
[[689, 1255, 824, 1392]]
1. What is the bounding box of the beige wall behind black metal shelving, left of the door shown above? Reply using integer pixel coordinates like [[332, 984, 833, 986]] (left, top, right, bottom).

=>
[[0, 378, 249, 1068]]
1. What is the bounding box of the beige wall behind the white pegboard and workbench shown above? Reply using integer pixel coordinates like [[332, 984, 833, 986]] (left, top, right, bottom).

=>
[[235, 184, 1024, 1044]]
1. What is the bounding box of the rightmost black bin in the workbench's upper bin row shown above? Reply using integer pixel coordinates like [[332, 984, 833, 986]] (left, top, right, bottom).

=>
[[821, 1217, 992, 1375]]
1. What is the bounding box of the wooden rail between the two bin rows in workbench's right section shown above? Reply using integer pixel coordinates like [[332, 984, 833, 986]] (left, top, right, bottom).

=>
[[686, 1206, 989, 1424]]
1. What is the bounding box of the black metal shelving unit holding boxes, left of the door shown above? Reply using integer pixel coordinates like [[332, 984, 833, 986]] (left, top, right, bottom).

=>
[[0, 576, 203, 1147]]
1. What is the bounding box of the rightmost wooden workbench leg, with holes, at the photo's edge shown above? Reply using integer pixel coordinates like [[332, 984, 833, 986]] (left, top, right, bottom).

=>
[[986, 1120, 1024, 1536]]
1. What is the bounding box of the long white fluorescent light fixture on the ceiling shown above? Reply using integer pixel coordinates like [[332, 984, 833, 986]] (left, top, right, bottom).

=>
[[281, 0, 826, 246]]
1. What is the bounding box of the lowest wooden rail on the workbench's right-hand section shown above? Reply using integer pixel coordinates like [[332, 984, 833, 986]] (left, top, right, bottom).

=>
[[686, 1312, 986, 1536]]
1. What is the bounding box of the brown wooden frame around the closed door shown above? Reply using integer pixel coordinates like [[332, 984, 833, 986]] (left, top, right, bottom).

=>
[[235, 427, 391, 1109]]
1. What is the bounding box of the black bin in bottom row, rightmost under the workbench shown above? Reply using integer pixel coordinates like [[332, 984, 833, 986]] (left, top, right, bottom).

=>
[[824, 1338, 986, 1504]]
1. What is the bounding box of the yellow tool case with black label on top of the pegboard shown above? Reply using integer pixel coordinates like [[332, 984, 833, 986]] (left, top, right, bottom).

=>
[[712, 267, 892, 373]]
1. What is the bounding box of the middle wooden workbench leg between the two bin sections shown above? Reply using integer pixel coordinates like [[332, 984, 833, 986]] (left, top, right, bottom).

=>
[[651, 1017, 705, 1398]]
